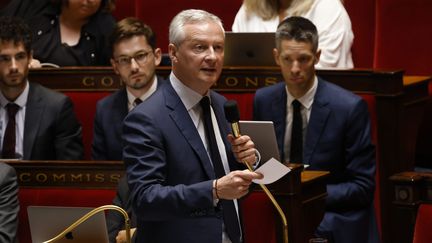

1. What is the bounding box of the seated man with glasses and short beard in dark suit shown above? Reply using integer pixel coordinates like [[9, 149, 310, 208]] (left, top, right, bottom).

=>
[[92, 18, 163, 242]]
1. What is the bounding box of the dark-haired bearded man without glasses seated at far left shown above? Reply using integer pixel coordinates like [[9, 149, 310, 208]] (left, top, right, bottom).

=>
[[0, 17, 84, 160]]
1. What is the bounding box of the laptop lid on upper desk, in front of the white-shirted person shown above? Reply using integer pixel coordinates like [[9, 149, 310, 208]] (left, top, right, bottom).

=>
[[224, 32, 276, 66]]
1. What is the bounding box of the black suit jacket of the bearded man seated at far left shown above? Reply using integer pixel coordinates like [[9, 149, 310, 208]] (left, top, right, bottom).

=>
[[23, 82, 84, 160]]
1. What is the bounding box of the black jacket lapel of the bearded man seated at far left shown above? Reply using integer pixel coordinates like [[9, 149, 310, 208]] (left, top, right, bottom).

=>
[[23, 82, 45, 160]]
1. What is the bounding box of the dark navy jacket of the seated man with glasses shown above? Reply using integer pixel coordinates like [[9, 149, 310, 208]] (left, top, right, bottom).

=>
[[92, 77, 165, 160]]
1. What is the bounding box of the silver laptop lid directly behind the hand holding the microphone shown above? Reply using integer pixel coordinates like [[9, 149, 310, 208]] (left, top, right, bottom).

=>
[[239, 121, 280, 163]]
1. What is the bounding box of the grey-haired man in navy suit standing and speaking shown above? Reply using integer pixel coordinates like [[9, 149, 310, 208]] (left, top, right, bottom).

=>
[[123, 10, 262, 243]]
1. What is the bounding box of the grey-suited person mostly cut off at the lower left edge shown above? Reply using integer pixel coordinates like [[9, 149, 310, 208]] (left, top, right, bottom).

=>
[[0, 163, 19, 243]]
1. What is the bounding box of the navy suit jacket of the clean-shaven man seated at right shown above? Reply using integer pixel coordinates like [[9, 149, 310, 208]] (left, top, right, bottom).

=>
[[254, 78, 379, 243]]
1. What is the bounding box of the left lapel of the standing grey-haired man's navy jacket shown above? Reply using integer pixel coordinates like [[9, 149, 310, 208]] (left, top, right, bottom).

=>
[[163, 83, 215, 178]]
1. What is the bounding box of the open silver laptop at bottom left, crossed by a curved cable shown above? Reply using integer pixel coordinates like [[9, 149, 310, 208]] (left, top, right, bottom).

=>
[[27, 206, 108, 243]]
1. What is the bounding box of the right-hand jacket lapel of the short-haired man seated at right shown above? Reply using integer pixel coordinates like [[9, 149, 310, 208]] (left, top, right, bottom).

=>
[[303, 80, 331, 164]]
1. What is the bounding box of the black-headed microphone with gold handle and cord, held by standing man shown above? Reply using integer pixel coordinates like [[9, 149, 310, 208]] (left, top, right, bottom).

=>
[[224, 100, 288, 243]]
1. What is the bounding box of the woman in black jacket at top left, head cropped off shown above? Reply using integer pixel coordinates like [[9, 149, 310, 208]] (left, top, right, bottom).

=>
[[29, 0, 115, 67]]
